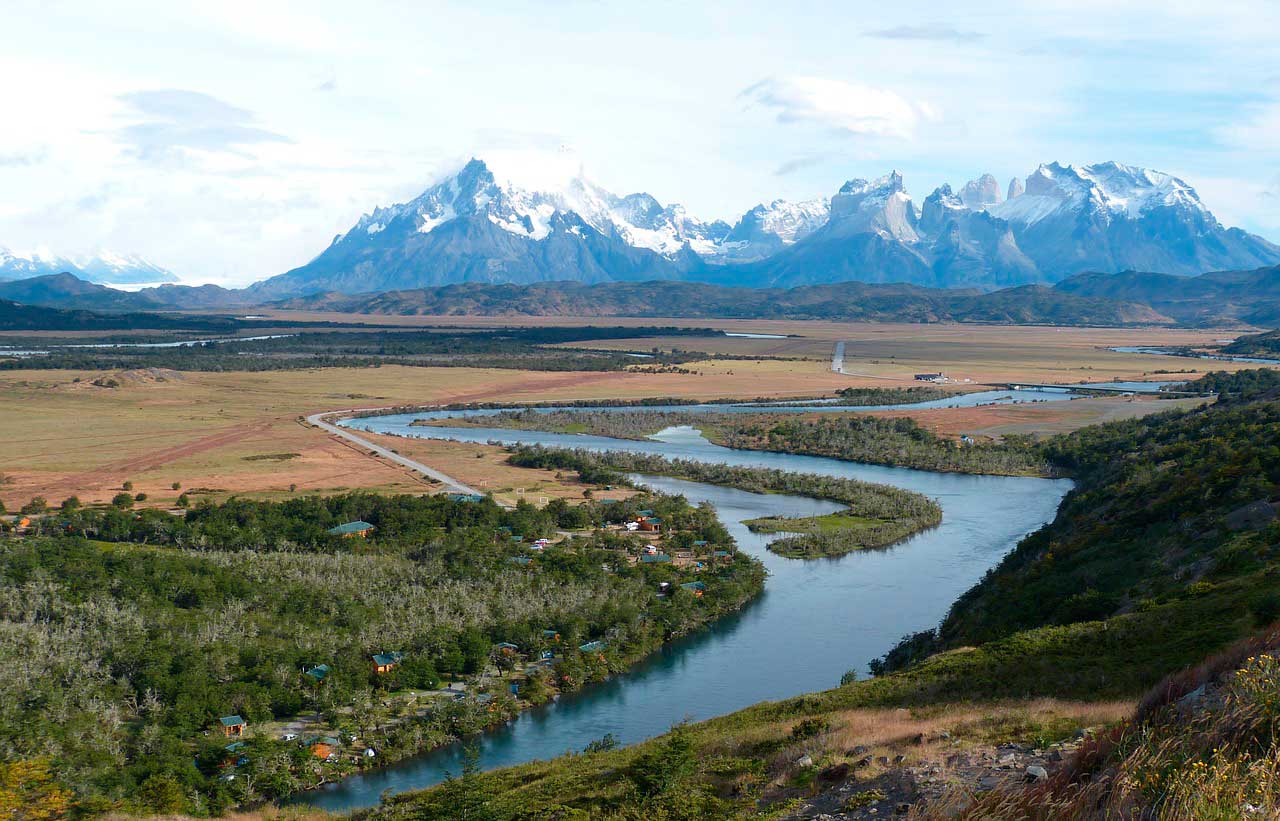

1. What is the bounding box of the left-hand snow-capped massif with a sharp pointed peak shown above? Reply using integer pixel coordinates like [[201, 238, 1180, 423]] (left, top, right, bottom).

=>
[[255, 159, 827, 296]]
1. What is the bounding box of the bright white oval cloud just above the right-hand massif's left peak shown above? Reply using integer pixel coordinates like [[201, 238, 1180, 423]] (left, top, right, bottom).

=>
[[740, 77, 938, 140]]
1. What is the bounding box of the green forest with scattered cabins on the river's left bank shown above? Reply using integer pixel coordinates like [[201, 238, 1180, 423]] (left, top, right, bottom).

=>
[[0, 493, 763, 815]]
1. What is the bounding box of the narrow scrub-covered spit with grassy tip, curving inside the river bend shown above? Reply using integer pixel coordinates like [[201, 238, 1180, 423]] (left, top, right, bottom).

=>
[[509, 447, 942, 558]]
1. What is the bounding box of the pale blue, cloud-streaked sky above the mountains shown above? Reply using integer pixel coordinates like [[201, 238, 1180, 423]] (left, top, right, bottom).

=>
[[0, 0, 1280, 286]]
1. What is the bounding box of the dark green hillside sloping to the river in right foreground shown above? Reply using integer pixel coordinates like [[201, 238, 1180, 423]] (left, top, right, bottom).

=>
[[369, 373, 1280, 820]]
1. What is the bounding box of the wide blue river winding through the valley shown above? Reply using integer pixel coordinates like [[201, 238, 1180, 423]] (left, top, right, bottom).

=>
[[294, 412, 1070, 812]]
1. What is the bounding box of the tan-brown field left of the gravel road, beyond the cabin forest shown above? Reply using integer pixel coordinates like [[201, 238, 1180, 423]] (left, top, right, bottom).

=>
[[0, 362, 841, 508]]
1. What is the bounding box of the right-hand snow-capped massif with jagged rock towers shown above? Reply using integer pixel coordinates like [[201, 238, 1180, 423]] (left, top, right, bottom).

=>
[[736, 163, 1280, 288]]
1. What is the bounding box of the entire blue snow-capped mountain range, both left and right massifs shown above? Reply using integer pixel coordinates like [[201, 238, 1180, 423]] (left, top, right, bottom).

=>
[[248, 159, 1280, 301]]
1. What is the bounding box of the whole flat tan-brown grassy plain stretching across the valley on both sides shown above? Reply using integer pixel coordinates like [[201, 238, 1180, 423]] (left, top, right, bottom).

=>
[[0, 316, 1259, 508]]
